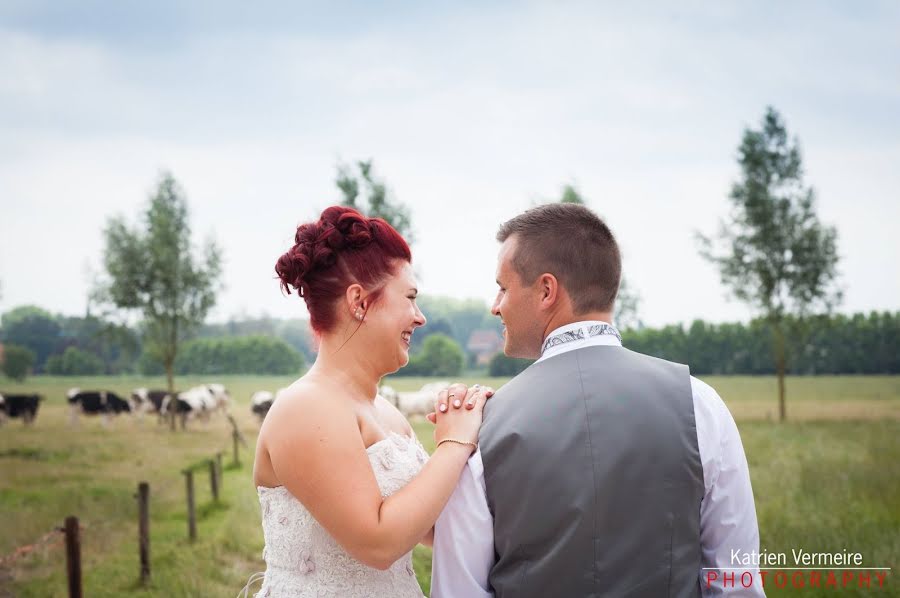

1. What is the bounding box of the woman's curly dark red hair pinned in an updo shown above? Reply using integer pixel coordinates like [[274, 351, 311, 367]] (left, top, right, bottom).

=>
[[275, 206, 412, 334]]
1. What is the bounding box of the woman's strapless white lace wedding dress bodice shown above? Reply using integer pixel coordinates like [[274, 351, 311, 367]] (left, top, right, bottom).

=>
[[256, 433, 428, 598]]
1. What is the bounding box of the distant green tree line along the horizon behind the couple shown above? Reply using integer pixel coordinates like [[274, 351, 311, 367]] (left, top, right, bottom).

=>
[[0, 296, 900, 376]]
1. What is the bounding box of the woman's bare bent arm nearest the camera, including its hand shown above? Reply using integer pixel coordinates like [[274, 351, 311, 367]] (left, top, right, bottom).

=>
[[267, 395, 484, 569]]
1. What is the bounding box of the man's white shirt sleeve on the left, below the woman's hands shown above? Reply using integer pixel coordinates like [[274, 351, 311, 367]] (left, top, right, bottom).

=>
[[431, 450, 494, 598]]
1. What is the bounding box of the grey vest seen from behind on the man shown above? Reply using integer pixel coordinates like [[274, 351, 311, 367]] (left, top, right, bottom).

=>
[[479, 346, 704, 598]]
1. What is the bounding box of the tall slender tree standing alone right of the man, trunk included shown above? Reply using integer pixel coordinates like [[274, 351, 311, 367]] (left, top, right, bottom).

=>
[[697, 107, 841, 421]]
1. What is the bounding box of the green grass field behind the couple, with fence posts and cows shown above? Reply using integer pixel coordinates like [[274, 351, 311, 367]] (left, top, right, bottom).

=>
[[0, 377, 900, 597]]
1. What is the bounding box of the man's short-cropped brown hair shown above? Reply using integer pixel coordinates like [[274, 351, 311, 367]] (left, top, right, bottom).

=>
[[497, 203, 622, 314]]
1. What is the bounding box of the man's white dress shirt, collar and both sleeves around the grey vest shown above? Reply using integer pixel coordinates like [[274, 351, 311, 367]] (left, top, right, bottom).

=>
[[431, 321, 765, 598]]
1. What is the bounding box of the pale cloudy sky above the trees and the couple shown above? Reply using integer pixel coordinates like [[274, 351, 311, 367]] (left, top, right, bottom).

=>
[[0, 0, 900, 326]]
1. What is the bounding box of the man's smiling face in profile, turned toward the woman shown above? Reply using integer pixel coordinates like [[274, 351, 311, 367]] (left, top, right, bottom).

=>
[[491, 235, 544, 359]]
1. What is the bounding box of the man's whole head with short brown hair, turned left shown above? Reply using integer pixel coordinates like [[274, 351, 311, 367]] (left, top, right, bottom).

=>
[[491, 203, 622, 359]]
